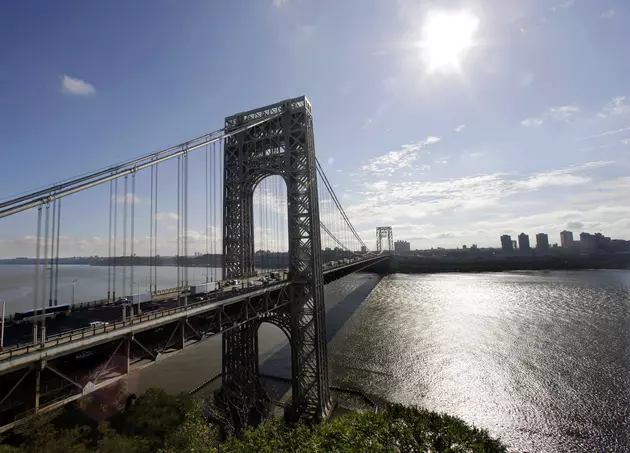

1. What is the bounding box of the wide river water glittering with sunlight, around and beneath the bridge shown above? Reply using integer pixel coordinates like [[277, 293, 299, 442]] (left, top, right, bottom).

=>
[[0, 266, 630, 452]]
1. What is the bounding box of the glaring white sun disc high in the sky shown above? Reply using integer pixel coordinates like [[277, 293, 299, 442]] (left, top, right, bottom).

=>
[[420, 11, 479, 73]]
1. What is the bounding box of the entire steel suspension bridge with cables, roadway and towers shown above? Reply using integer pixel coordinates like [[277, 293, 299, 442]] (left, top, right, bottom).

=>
[[0, 97, 392, 430]]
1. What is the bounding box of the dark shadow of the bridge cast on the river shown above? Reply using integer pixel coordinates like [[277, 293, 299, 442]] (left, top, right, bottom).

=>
[[260, 274, 380, 397]]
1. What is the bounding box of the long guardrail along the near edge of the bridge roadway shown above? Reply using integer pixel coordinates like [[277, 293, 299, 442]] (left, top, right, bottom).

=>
[[0, 260, 382, 361]]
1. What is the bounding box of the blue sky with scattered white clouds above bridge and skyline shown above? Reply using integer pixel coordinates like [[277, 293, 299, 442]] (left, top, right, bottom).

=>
[[0, 0, 630, 256]]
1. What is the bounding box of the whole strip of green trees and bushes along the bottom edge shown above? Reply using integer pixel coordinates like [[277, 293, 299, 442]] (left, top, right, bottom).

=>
[[0, 390, 506, 453]]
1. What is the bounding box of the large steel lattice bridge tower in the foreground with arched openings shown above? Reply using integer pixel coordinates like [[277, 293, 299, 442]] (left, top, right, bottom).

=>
[[222, 96, 331, 421]]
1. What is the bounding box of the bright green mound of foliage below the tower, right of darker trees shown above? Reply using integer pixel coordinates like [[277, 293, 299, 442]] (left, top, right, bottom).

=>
[[219, 406, 506, 453]]
